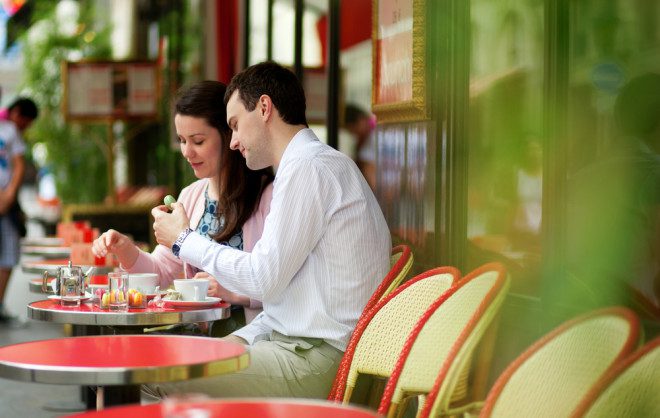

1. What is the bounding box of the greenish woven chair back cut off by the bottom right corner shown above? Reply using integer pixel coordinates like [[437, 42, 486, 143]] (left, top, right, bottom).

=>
[[571, 337, 660, 418]]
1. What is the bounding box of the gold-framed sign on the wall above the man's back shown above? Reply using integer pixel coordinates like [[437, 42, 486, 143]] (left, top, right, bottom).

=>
[[372, 0, 428, 123]]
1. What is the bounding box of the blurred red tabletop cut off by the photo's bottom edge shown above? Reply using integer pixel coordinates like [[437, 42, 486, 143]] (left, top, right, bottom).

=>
[[64, 399, 381, 418]]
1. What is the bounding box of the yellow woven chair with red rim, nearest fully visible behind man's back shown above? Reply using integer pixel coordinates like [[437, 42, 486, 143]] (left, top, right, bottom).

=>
[[329, 267, 460, 403]]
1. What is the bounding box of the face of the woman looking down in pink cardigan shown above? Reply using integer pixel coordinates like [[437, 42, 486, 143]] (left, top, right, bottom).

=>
[[174, 114, 222, 179]]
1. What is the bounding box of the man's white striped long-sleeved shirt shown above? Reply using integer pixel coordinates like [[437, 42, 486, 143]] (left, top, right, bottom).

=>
[[180, 129, 392, 350]]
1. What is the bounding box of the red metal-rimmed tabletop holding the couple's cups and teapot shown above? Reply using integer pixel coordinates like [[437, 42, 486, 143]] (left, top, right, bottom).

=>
[[28, 299, 231, 326]]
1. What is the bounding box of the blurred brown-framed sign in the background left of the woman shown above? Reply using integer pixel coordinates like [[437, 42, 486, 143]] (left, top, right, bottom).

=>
[[62, 61, 159, 120]]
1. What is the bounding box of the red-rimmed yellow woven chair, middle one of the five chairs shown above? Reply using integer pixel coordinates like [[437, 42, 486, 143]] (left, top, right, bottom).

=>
[[378, 263, 510, 417]]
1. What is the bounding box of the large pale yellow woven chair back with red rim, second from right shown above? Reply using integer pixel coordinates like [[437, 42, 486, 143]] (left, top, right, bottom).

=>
[[458, 308, 640, 418]]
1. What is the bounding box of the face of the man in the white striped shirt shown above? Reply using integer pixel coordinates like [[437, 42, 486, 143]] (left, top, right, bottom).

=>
[[227, 90, 273, 170]]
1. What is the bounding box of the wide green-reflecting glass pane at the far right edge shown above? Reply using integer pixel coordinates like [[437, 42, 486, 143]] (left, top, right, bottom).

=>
[[556, 0, 660, 317]]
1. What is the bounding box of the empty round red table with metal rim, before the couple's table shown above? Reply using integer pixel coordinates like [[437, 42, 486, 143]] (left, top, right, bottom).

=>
[[0, 335, 249, 409]]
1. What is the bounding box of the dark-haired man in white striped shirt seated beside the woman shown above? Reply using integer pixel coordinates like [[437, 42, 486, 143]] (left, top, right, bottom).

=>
[[145, 62, 391, 398]]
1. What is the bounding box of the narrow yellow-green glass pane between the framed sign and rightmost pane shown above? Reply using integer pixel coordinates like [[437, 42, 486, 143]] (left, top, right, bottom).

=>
[[467, 0, 544, 294]]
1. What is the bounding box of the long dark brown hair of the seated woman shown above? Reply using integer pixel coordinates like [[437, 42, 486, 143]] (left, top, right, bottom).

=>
[[174, 80, 273, 242]]
